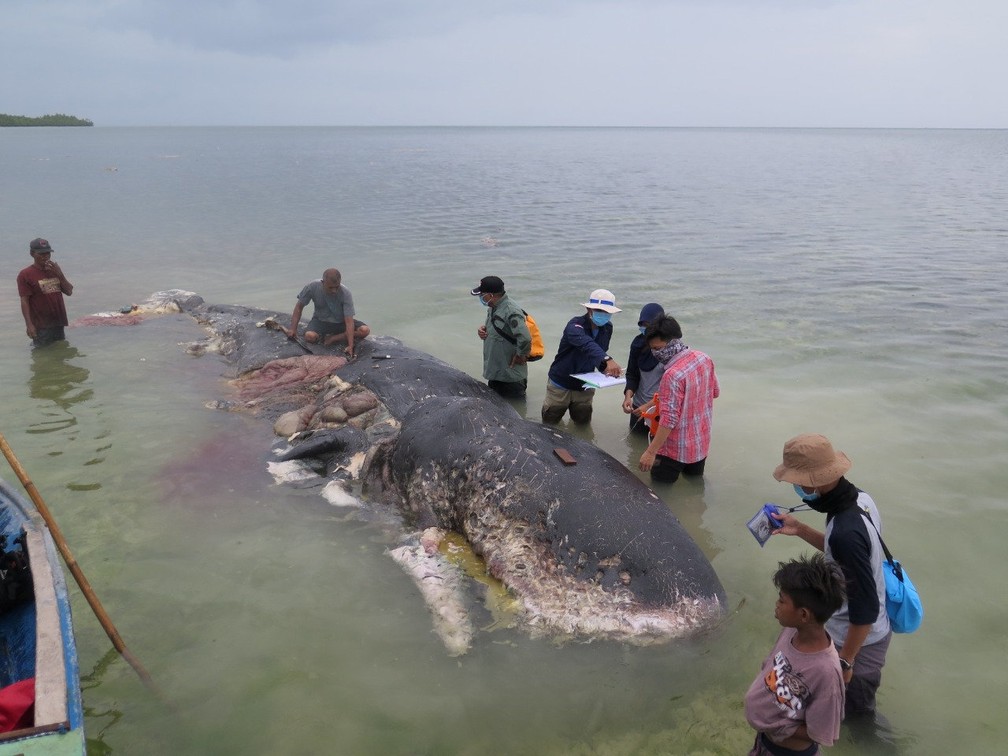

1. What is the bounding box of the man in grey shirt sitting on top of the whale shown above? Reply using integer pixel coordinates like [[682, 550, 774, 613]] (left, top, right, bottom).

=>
[[284, 268, 371, 357]]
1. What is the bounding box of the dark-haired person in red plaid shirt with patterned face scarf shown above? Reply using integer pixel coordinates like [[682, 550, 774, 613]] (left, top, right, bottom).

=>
[[640, 316, 721, 483]]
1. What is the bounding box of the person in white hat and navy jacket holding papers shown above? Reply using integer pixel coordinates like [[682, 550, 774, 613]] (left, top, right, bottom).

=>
[[542, 288, 623, 424]]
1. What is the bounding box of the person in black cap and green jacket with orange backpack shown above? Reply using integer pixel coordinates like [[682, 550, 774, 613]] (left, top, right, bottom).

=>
[[469, 275, 532, 399]]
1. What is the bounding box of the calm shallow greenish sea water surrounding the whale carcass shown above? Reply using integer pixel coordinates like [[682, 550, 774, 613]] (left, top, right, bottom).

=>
[[0, 128, 1008, 756]]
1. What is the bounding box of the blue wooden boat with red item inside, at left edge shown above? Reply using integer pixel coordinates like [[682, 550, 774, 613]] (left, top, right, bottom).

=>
[[0, 479, 86, 756]]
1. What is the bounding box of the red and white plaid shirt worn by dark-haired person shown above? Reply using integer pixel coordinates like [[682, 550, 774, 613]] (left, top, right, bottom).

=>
[[658, 349, 721, 465]]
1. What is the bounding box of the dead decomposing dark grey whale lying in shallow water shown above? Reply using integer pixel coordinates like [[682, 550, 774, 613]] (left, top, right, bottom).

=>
[[140, 291, 726, 652]]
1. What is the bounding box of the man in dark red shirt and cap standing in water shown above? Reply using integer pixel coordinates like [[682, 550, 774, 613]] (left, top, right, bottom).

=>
[[17, 239, 74, 347]]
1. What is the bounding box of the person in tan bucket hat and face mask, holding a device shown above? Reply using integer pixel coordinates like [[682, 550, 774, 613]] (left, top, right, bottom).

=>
[[773, 433, 892, 720]]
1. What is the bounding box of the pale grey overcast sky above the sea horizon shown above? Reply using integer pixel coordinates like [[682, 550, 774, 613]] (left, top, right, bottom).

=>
[[0, 0, 1008, 128]]
